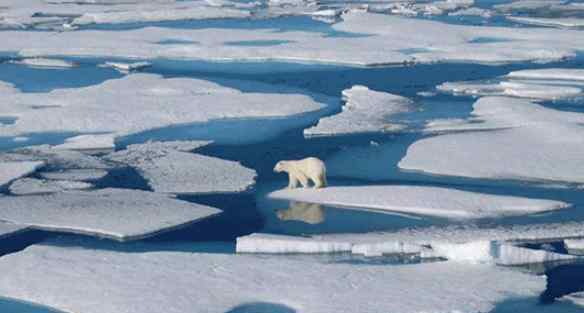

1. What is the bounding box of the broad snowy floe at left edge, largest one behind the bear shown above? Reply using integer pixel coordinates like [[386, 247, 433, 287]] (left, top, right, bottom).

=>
[[0, 73, 329, 141]]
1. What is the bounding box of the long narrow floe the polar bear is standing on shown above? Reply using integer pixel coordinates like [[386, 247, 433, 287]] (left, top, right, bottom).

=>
[[268, 185, 568, 219]]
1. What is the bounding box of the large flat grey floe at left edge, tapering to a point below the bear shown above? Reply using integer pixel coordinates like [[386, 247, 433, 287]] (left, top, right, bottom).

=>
[[0, 189, 221, 240]]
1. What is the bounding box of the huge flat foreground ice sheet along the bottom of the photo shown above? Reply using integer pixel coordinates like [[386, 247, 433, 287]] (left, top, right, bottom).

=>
[[0, 244, 545, 313]]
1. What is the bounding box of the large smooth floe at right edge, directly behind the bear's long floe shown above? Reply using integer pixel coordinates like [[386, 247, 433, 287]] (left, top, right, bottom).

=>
[[398, 97, 584, 184]]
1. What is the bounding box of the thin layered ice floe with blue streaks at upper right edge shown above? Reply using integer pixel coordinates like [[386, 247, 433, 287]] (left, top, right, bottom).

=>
[[436, 68, 584, 100]]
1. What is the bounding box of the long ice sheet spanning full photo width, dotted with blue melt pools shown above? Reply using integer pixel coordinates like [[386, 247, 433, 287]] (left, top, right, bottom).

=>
[[0, 12, 584, 65]]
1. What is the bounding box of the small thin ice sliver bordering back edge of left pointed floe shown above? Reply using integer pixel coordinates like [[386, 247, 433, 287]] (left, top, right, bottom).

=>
[[9, 178, 93, 195]]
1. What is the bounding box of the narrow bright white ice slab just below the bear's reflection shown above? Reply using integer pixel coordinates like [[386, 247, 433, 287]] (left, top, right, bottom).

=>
[[236, 234, 352, 253]]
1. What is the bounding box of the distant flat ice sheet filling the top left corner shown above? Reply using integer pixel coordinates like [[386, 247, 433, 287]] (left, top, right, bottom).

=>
[[0, 0, 250, 30]]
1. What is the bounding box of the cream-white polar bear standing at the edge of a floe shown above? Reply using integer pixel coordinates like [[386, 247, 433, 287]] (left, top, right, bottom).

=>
[[274, 158, 327, 189]]
